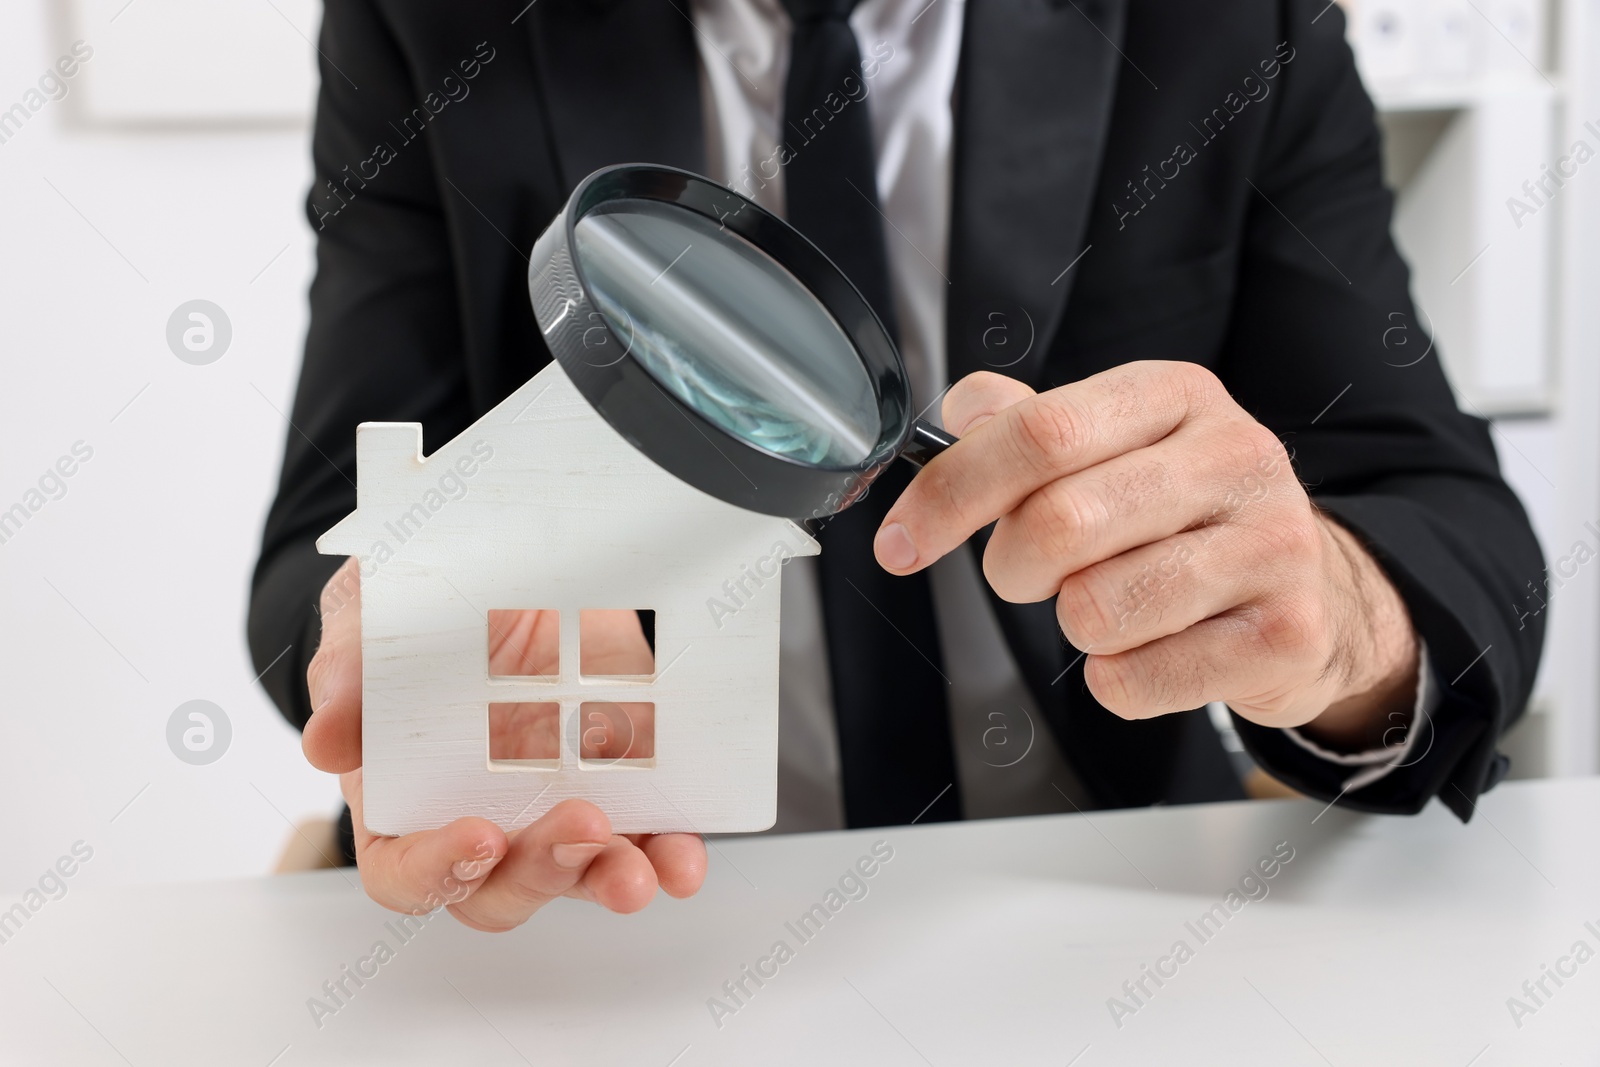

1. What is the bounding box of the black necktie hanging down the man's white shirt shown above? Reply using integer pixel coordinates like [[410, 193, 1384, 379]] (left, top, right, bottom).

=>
[[781, 0, 962, 827]]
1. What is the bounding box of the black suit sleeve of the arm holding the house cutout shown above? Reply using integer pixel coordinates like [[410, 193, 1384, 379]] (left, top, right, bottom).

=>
[[248, 0, 470, 726]]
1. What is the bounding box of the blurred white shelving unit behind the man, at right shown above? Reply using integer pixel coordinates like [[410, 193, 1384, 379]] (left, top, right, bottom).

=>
[[1341, 0, 1600, 774]]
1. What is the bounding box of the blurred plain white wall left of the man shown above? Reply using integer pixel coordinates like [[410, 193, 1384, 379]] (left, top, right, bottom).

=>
[[0, 0, 338, 894]]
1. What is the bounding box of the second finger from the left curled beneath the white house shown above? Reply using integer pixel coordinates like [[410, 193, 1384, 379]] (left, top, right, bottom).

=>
[[450, 800, 617, 931]]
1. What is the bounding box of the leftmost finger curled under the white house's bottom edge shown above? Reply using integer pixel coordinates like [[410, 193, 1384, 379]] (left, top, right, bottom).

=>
[[339, 771, 507, 915]]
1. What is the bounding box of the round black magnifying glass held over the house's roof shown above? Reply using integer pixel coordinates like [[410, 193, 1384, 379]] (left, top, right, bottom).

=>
[[528, 165, 955, 518]]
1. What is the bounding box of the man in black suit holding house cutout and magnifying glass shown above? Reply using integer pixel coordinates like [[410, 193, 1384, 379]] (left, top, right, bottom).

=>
[[250, 0, 1542, 929]]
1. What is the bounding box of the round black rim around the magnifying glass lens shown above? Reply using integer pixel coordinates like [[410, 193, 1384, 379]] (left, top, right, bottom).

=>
[[528, 163, 914, 518]]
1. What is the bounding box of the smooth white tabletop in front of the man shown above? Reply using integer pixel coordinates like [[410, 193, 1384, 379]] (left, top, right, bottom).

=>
[[0, 781, 1600, 1067]]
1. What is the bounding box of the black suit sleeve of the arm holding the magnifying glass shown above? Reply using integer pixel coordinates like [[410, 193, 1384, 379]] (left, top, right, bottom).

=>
[[1221, 0, 1544, 819]]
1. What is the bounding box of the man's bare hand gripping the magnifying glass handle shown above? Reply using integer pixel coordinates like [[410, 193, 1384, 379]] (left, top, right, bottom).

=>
[[874, 362, 1419, 750]]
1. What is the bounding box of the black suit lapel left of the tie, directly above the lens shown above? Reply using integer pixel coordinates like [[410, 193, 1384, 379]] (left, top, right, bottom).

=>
[[523, 0, 706, 195]]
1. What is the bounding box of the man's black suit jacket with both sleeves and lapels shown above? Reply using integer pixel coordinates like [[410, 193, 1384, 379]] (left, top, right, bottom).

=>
[[250, 0, 1542, 817]]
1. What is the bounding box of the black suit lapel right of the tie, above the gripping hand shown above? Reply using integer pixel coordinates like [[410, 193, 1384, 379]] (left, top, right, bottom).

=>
[[946, 0, 1126, 382]]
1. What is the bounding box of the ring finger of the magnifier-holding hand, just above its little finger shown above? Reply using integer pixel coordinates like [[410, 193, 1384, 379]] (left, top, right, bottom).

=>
[[1056, 525, 1278, 656]]
